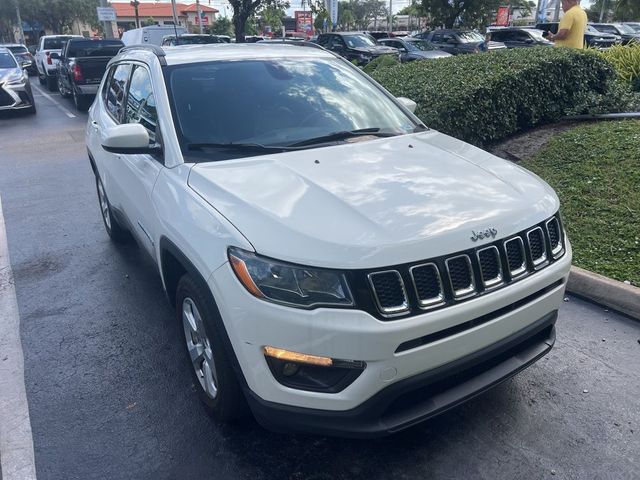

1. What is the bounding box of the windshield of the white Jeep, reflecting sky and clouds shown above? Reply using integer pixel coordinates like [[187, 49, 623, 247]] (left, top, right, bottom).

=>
[[165, 57, 417, 160]]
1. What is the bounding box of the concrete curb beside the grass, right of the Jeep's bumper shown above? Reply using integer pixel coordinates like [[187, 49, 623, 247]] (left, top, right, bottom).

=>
[[567, 266, 640, 320]]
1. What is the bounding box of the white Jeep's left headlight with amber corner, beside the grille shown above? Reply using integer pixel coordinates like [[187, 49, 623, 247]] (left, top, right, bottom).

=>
[[228, 247, 353, 308]]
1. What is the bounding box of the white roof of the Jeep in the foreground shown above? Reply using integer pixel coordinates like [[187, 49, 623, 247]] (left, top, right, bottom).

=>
[[116, 42, 335, 65]]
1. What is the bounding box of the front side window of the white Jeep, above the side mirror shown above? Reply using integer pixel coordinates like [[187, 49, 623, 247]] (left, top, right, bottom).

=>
[[124, 67, 158, 144]]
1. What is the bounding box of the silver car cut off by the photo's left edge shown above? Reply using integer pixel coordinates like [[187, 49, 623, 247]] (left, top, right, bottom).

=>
[[0, 47, 36, 113]]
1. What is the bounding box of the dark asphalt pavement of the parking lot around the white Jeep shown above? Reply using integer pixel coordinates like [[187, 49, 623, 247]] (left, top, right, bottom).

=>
[[0, 81, 640, 480]]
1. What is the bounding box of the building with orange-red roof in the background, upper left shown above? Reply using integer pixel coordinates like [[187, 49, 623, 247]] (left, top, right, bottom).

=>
[[111, 2, 218, 32]]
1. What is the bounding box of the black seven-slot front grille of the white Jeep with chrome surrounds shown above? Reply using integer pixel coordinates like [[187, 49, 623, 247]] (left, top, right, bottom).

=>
[[358, 215, 565, 318]]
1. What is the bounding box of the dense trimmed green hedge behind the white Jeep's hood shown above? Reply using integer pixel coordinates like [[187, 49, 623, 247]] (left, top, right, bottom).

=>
[[371, 47, 616, 145]]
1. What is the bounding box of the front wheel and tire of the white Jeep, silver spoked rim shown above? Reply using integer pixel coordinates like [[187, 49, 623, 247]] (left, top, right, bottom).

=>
[[176, 274, 248, 422]]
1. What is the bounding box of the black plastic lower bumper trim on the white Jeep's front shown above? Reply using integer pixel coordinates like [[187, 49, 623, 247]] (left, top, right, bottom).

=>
[[245, 311, 558, 438]]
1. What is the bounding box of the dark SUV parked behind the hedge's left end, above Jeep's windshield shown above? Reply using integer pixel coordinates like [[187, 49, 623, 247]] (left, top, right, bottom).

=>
[[316, 32, 398, 66]]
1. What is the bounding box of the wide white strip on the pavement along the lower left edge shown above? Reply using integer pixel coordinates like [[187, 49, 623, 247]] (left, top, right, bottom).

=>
[[0, 199, 36, 480]]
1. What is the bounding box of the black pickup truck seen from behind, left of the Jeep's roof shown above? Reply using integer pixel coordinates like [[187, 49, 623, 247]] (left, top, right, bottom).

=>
[[51, 38, 124, 111]]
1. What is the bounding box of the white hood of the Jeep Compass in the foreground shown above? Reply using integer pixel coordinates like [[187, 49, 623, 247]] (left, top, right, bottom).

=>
[[188, 131, 558, 268]]
